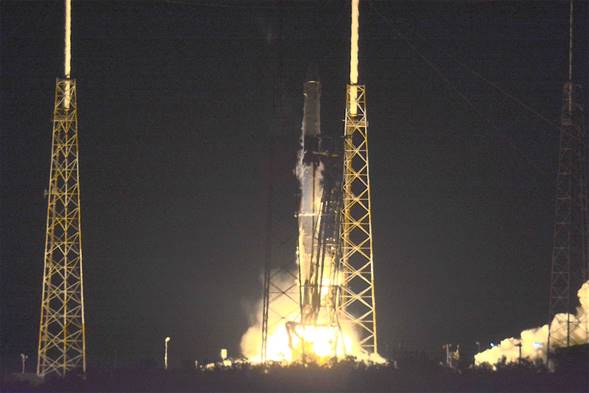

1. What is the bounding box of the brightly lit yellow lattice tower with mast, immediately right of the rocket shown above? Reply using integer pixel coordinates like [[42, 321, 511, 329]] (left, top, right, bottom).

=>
[[339, 0, 377, 354]]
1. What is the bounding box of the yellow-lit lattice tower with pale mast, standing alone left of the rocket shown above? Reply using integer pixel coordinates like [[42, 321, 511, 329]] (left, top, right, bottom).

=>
[[37, 0, 86, 376]]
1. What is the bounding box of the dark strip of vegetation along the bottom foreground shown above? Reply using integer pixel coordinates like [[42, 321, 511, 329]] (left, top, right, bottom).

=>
[[2, 350, 589, 392]]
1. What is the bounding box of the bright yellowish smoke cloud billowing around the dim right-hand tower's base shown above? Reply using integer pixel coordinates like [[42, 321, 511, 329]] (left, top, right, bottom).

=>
[[474, 281, 589, 366]]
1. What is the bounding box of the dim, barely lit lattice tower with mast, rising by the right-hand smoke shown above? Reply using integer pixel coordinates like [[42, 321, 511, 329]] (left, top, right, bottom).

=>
[[547, 0, 589, 358]]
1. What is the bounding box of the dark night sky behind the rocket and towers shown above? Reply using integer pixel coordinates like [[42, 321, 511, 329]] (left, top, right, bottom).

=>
[[0, 0, 589, 369]]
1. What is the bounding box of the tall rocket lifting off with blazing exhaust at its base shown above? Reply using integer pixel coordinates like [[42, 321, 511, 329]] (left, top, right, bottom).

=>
[[287, 76, 345, 362]]
